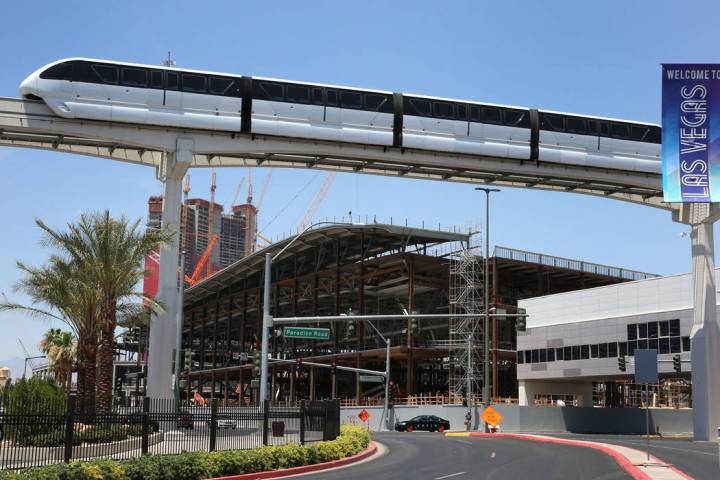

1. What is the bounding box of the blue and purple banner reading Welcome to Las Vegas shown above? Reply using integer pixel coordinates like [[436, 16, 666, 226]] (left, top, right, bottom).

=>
[[662, 64, 720, 203]]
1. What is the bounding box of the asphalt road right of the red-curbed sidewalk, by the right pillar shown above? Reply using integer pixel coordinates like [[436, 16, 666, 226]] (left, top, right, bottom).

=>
[[553, 434, 720, 480]]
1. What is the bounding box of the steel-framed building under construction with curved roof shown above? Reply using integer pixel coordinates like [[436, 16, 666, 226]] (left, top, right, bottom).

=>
[[181, 223, 647, 405]]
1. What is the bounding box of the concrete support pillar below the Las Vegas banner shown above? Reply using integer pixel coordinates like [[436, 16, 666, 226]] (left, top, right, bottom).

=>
[[673, 203, 720, 441]]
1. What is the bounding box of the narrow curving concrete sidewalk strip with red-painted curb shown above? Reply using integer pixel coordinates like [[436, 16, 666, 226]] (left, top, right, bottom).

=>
[[445, 432, 692, 480]]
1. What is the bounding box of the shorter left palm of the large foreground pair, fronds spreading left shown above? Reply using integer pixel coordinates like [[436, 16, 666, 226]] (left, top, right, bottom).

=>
[[0, 255, 100, 413]]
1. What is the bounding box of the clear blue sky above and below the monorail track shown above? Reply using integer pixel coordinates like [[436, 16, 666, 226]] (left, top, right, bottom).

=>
[[0, 0, 720, 359]]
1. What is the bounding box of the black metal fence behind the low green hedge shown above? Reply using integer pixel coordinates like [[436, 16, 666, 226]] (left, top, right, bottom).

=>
[[0, 396, 340, 469]]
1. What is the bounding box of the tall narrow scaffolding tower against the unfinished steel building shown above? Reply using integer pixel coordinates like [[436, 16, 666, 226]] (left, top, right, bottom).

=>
[[449, 232, 485, 400]]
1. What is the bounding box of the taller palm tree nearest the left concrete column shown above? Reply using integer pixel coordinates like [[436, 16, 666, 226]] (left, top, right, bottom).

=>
[[36, 210, 175, 413]]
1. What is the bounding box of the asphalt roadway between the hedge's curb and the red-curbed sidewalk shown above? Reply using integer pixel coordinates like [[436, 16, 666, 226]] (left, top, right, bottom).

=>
[[293, 432, 631, 480]]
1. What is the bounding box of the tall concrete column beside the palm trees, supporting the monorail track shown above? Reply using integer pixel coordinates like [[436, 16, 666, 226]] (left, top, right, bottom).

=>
[[147, 139, 193, 399]]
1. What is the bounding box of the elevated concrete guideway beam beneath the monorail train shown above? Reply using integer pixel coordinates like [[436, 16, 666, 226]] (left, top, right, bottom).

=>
[[0, 97, 666, 208]]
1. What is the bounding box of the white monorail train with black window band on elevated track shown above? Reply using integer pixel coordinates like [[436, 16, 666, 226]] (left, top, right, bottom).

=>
[[20, 58, 661, 174]]
